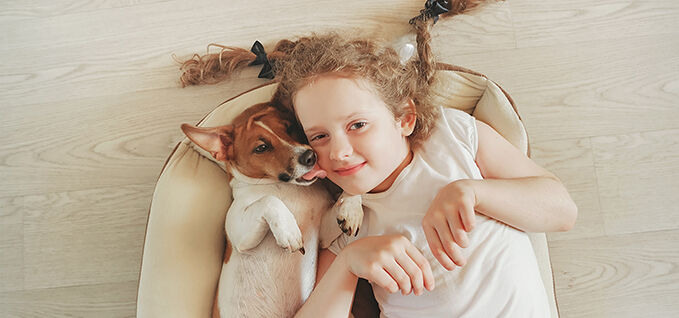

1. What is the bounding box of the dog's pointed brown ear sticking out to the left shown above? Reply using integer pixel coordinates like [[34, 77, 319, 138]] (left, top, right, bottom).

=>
[[182, 124, 233, 161]]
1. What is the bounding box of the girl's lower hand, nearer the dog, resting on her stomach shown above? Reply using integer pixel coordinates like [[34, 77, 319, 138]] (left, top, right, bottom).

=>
[[338, 235, 434, 295]]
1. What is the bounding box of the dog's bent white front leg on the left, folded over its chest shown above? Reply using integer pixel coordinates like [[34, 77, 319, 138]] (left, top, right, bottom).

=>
[[226, 195, 304, 253]]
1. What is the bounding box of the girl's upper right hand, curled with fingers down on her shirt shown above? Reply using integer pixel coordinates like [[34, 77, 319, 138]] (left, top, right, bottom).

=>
[[422, 180, 476, 270]]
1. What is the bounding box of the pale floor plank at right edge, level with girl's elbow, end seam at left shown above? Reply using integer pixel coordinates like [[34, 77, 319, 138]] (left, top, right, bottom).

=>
[[592, 129, 679, 235]]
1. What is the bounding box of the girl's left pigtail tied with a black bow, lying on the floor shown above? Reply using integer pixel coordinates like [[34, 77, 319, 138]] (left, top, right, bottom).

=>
[[178, 40, 295, 87]]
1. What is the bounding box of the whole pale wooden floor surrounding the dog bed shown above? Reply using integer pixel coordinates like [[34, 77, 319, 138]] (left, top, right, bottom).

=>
[[0, 0, 679, 317]]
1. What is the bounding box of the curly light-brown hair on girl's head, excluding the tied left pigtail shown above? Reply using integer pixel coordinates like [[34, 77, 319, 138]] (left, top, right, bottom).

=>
[[274, 27, 438, 146]]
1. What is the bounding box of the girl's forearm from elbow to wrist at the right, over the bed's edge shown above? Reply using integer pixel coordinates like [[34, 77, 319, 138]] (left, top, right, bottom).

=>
[[464, 176, 578, 232]]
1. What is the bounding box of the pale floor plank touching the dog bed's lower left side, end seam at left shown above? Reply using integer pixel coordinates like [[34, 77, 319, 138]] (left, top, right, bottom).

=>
[[24, 186, 153, 289]]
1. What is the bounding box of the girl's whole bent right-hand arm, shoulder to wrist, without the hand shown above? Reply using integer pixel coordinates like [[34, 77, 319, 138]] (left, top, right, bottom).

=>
[[467, 121, 578, 232]]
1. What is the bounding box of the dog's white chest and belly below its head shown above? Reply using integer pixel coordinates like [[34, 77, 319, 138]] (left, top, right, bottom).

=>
[[218, 184, 330, 317]]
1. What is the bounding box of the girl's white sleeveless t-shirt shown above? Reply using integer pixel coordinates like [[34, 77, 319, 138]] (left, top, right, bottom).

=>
[[329, 108, 550, 318]]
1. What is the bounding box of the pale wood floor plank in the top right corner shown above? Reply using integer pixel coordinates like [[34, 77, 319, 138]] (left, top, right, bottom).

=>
[[508, 0, 679, 48]]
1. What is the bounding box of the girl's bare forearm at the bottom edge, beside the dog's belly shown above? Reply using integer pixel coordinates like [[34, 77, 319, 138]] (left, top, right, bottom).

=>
[[295, 254, 358, 318]]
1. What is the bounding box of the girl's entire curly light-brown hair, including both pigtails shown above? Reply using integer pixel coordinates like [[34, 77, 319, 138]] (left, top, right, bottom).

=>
[[181, 0, 492, 147]]
